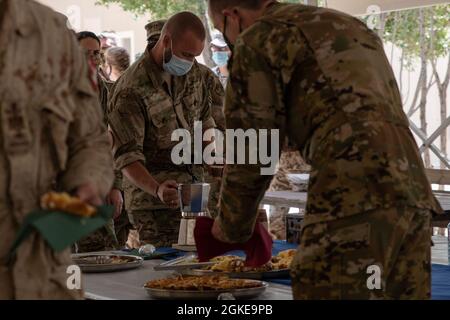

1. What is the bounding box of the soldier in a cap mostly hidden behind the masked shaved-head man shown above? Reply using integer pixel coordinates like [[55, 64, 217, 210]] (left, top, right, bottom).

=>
[[145, 20, 225, 217]]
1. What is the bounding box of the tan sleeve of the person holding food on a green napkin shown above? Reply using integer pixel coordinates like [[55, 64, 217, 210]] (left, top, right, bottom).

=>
[[61, 35, 113, 196]]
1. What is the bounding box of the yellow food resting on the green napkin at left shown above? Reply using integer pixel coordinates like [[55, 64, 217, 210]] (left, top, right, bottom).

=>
[[41, 192, 97, 217]]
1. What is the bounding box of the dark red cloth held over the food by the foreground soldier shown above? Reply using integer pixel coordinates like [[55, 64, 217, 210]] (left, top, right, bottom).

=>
[[194, 217, 273, 267]]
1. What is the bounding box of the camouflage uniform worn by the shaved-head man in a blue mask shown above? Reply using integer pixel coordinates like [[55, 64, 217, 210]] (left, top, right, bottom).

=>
[[108, 46, 215, 246]]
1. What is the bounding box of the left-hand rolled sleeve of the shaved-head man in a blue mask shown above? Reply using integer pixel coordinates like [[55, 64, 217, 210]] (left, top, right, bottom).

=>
[[108, 87, 146, 170]]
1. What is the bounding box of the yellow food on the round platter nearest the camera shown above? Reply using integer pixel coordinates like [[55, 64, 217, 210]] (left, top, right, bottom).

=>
[[145, 276, 262, 291]]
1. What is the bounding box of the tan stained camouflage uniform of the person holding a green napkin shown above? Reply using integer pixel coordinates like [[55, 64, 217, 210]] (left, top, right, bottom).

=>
[[0, 0, 113, 299]]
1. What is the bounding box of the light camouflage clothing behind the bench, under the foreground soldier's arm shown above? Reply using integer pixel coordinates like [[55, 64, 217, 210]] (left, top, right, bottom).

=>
[[269, 150, 310, 240]]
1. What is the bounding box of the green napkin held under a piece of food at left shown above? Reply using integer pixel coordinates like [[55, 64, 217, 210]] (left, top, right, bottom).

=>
[[10, 206, 114, 257]]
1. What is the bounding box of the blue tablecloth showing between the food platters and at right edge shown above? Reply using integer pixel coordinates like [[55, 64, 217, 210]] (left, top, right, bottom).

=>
[[158, 241, 450, 300]]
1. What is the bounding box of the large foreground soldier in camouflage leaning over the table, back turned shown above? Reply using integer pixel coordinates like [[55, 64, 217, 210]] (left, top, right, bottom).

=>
[[209, 0, 442, 299]]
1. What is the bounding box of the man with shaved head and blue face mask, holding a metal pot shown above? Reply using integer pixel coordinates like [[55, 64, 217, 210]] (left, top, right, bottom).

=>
[[108, 12, 215, 246]]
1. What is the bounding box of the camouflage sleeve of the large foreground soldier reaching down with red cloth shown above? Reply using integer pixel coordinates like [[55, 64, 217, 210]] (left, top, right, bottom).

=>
[[218, 40, 283, 243]]
